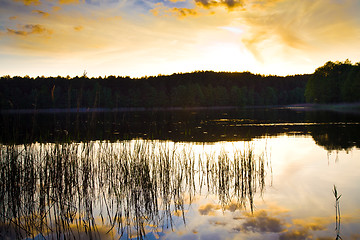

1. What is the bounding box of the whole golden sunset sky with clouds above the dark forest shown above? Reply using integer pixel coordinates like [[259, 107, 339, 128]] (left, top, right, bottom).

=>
[[0, 0, 360, 77]]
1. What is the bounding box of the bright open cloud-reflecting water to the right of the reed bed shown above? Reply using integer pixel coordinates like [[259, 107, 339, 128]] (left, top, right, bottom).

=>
[[153, 136, 360, 240]]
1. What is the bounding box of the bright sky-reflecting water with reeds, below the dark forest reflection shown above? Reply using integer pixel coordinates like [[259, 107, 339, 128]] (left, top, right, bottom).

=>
[[0, 137, 360, 240]]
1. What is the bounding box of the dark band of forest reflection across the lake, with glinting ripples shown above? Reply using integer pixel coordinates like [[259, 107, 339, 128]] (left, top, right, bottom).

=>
[[0, 109, 360, 150]]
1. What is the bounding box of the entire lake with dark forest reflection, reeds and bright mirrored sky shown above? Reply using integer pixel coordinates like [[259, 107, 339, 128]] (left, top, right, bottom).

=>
[[0, 108, 360, 240]]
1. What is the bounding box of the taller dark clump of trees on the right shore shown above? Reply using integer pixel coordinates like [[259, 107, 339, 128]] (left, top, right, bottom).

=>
[[305, 60, 360, 103]]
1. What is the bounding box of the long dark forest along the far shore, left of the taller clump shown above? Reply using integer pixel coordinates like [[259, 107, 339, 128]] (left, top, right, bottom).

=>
[[0, 71, 310, 109]]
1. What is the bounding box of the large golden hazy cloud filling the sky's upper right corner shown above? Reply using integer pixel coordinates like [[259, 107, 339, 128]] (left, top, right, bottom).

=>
[[242, 0, 359, 61]]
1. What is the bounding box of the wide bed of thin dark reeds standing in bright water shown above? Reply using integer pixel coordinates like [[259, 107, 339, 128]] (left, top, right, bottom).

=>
[[0, 140, 267, 239]]
